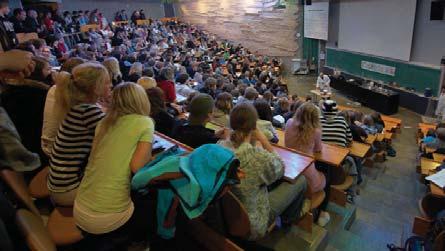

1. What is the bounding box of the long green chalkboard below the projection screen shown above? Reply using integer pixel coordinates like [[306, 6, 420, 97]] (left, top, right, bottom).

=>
[[326, 48, 440, 95]]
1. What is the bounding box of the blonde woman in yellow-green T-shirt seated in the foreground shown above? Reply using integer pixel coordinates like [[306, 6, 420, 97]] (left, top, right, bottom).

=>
[[74, 83, 154, 238]]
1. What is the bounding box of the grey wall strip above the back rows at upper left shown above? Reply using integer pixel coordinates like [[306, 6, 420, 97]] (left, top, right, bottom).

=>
[[62, 0, 164, 21]]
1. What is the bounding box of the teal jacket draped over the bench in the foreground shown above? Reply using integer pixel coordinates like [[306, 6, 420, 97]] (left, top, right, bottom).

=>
[[131, 144, 235, 239]]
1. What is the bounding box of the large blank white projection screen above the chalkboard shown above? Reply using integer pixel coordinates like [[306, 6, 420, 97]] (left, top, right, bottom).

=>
[[338, 0, 416, 61]]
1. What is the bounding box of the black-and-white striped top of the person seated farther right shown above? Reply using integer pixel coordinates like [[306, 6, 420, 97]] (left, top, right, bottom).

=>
[[320, 112, 352, 147]]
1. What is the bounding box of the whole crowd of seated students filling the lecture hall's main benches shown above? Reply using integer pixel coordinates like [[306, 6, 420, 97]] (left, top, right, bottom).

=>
[[0, 2, 398, 249]]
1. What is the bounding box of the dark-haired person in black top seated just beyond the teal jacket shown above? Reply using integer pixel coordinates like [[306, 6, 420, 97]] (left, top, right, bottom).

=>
[[173, 93, 228, 148]]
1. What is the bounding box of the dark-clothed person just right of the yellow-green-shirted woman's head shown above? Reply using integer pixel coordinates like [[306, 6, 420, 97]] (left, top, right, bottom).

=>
[[146, 87, 177, 136]]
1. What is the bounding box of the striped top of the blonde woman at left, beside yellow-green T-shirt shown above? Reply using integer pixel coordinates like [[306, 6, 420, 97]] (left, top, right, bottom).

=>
[[48, 104, 105, 193]]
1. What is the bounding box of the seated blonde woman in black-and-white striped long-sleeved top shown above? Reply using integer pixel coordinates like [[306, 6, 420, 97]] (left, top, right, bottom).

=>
[[48, 63, 111, 206]]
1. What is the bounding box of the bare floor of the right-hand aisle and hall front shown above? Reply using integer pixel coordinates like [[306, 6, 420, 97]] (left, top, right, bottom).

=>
[[287, 73, 425, 251]]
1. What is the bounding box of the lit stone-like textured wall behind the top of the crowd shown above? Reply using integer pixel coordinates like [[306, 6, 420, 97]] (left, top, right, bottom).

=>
[[179, 0, 299, 56]]
